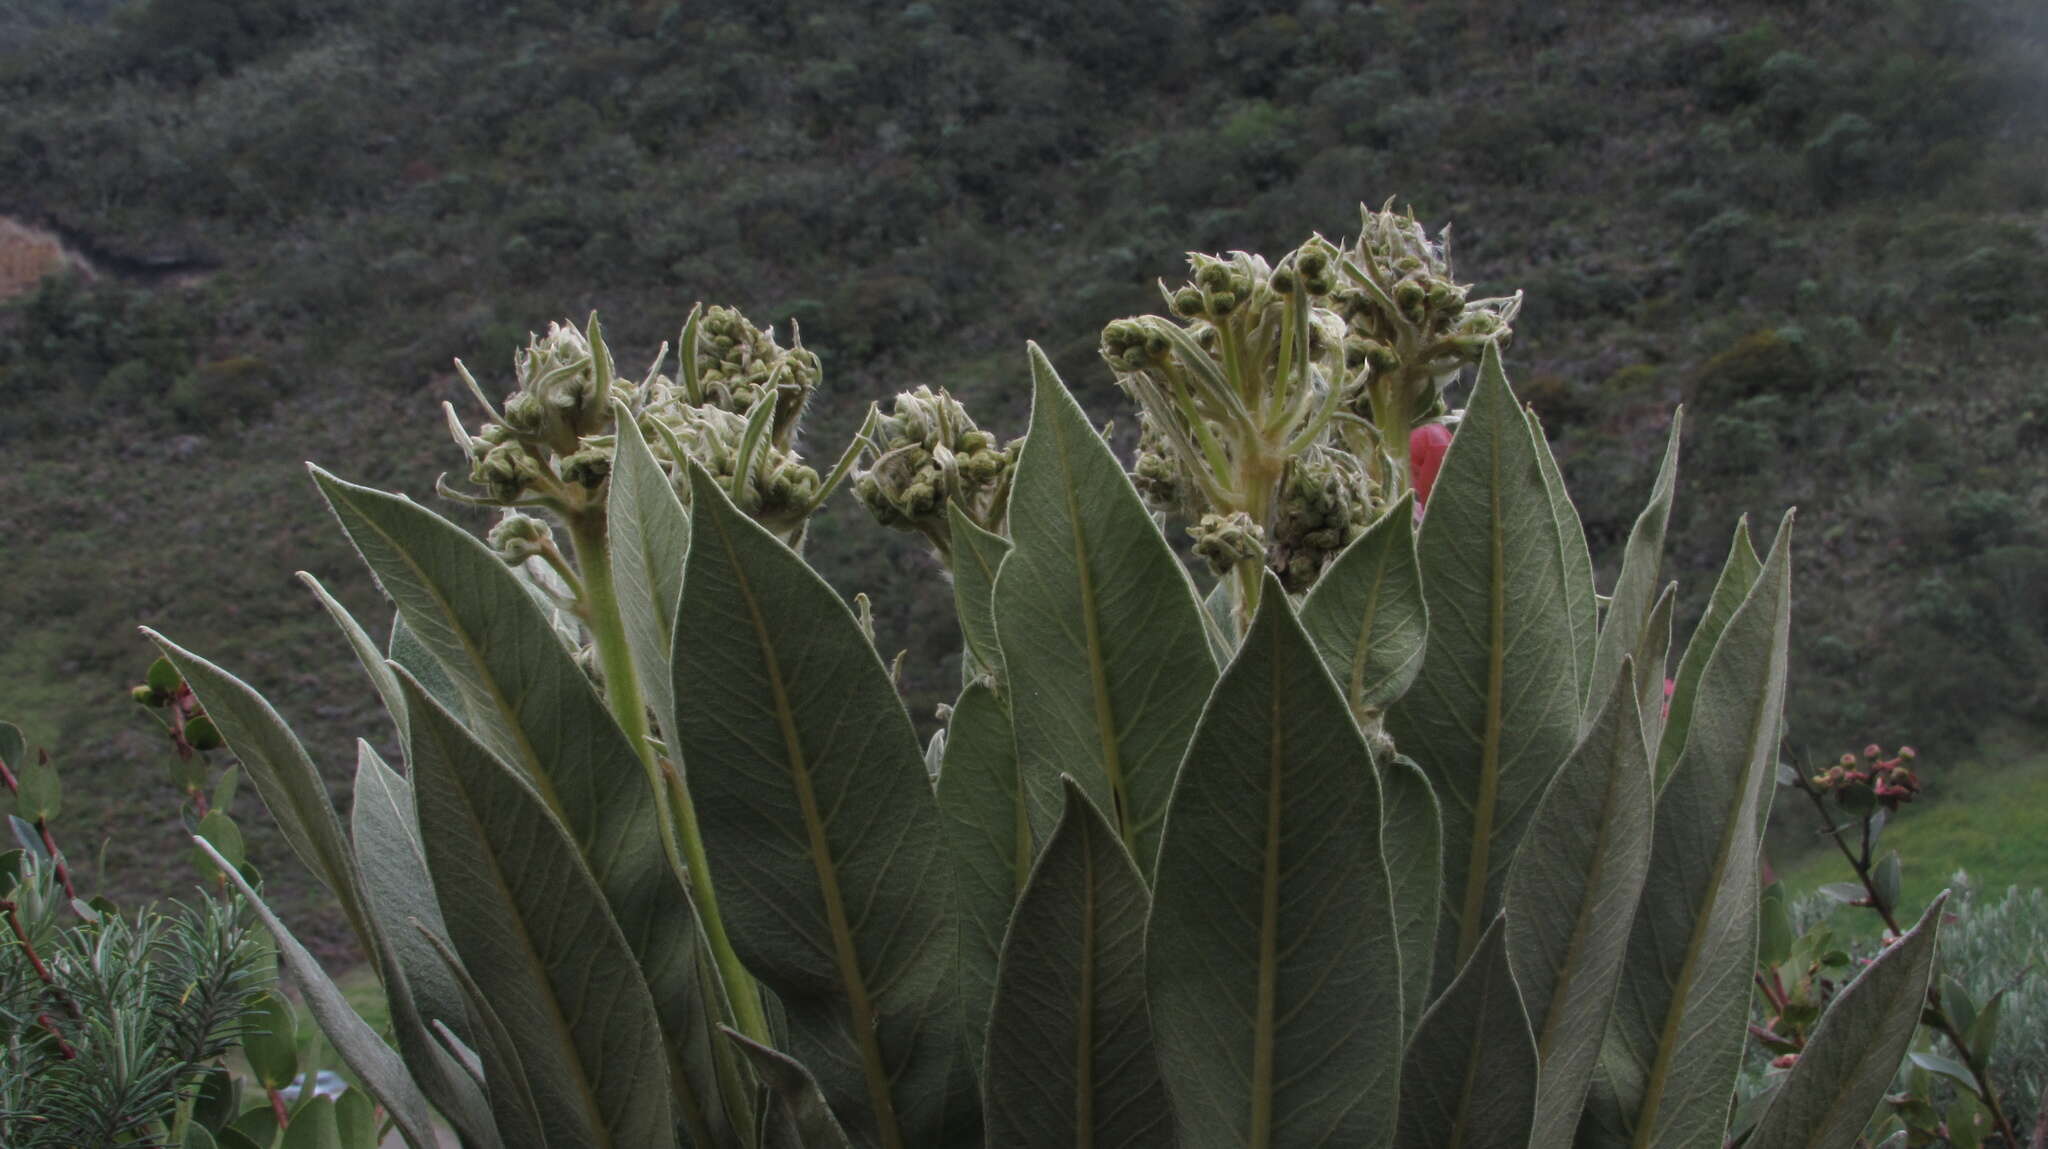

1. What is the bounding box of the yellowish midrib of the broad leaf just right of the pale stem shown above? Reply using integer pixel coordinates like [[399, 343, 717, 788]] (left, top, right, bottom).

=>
[[709, 505, 903, 1149]]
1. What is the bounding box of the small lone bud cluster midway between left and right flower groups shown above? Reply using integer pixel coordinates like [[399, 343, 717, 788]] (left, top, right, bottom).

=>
[[854, 387, 1020, 553]]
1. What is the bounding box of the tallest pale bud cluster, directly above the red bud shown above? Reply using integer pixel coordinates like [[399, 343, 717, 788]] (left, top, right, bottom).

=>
[[1331, 203, 1522, 428]]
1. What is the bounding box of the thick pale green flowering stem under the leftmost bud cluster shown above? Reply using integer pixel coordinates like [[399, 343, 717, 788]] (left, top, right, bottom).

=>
[[567, 506, 770, 1042]]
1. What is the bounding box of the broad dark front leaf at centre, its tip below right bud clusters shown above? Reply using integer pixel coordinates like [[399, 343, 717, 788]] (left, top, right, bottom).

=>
[[1145, 573, 1401, 1149]]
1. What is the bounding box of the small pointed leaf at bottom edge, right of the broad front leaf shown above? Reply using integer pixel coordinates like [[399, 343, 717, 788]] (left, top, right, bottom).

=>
[[1393, 918, 1538, 1149]]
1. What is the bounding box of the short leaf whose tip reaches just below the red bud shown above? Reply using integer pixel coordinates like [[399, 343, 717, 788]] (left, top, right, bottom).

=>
[[1300, 492, 1430, 721]]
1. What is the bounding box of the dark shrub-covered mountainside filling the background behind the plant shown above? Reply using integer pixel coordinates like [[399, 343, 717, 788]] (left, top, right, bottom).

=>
[[0, 0, 2048, 938]]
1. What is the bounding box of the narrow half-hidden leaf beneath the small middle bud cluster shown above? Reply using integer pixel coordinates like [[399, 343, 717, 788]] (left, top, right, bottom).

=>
[[938, 684, 1032, 1067]]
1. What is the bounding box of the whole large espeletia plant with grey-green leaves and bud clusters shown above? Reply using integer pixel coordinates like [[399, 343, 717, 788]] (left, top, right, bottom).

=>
[[158, 211, 1933, 1149]]
